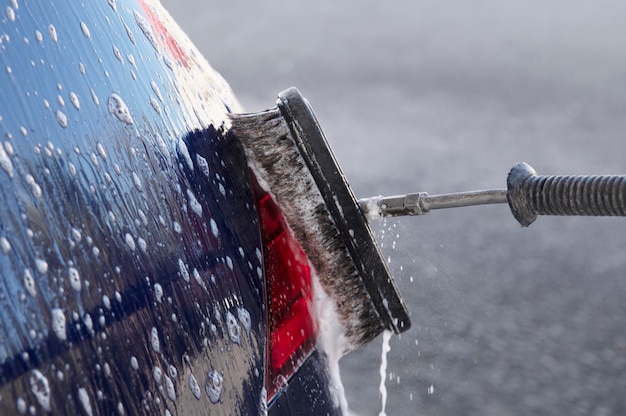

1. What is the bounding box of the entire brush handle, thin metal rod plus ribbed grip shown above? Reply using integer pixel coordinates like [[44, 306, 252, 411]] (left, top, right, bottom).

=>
[[359, 163, 626, 227]]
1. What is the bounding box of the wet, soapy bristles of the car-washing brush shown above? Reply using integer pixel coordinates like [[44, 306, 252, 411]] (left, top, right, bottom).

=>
[[231, 108, 385, 352]]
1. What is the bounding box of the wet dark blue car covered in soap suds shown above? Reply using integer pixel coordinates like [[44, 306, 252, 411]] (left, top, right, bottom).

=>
[[0, 0, 360, 415]]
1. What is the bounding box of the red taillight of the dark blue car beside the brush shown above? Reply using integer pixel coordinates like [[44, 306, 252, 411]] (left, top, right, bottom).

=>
[[253, 179, 316, 402]]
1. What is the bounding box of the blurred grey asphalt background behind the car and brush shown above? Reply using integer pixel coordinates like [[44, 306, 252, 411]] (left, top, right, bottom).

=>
[[164, 0, 626, 416]]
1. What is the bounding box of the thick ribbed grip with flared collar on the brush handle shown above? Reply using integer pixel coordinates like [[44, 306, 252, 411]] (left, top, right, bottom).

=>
[[507, 163, 626, 227]]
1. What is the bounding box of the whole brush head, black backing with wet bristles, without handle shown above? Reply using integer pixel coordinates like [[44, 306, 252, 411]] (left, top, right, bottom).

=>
[[231, 88, 410, 352]]
